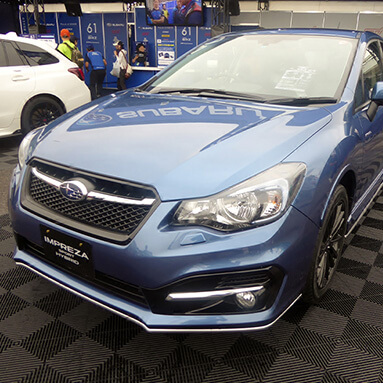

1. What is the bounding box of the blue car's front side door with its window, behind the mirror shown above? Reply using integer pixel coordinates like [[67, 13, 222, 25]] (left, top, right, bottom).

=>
[[354, 41, 383, 197]]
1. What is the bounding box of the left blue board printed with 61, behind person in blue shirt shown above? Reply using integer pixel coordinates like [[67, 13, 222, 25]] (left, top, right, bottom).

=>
[[81, 13, 105, 84]]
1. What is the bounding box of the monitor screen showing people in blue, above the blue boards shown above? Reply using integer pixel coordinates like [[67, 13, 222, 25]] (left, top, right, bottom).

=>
[[145, 0, 203, 26]]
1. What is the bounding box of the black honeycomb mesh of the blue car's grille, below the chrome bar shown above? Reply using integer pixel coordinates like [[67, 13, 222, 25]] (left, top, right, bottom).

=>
[[29, 164, 151, 235]]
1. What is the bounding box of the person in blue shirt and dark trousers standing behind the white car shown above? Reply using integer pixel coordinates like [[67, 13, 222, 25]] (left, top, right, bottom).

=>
[[85, 44, 106, 100]]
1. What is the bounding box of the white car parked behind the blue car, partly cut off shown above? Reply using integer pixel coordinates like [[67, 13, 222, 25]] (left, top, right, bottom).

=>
[[0, 32, 91, 137]]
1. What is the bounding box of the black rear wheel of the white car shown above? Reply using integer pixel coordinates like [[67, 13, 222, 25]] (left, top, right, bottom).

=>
[[21, 96, 65, 135]]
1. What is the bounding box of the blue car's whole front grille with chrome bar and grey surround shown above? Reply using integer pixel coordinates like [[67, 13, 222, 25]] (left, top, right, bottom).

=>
[[22, 161, 158, 242]]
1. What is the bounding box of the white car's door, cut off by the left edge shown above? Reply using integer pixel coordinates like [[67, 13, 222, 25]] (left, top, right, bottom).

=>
[[0, 40, 35, 134]]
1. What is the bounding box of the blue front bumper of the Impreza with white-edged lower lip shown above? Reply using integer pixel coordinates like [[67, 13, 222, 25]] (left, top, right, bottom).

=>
[[10, 165, 318, 332]]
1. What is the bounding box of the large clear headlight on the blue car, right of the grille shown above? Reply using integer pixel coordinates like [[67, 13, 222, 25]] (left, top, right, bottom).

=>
[[174, 163, 306, 231]]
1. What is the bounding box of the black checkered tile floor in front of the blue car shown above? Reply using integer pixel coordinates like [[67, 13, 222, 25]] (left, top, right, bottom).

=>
[[0, 142, 383, 383]]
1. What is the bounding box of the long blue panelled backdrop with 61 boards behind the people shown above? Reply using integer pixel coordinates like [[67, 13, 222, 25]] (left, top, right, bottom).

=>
[[20, 8, 216, 88]]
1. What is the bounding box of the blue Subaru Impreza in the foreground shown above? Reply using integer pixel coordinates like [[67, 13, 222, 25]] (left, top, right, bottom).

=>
[[9, 29, 383, 331]]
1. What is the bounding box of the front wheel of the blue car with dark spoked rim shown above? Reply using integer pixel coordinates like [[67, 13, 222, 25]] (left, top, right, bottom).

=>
[[302, 185, 349, 304]]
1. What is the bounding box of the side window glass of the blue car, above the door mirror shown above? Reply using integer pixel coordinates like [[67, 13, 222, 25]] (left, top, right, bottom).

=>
[[362, 42, 382, 102]]
